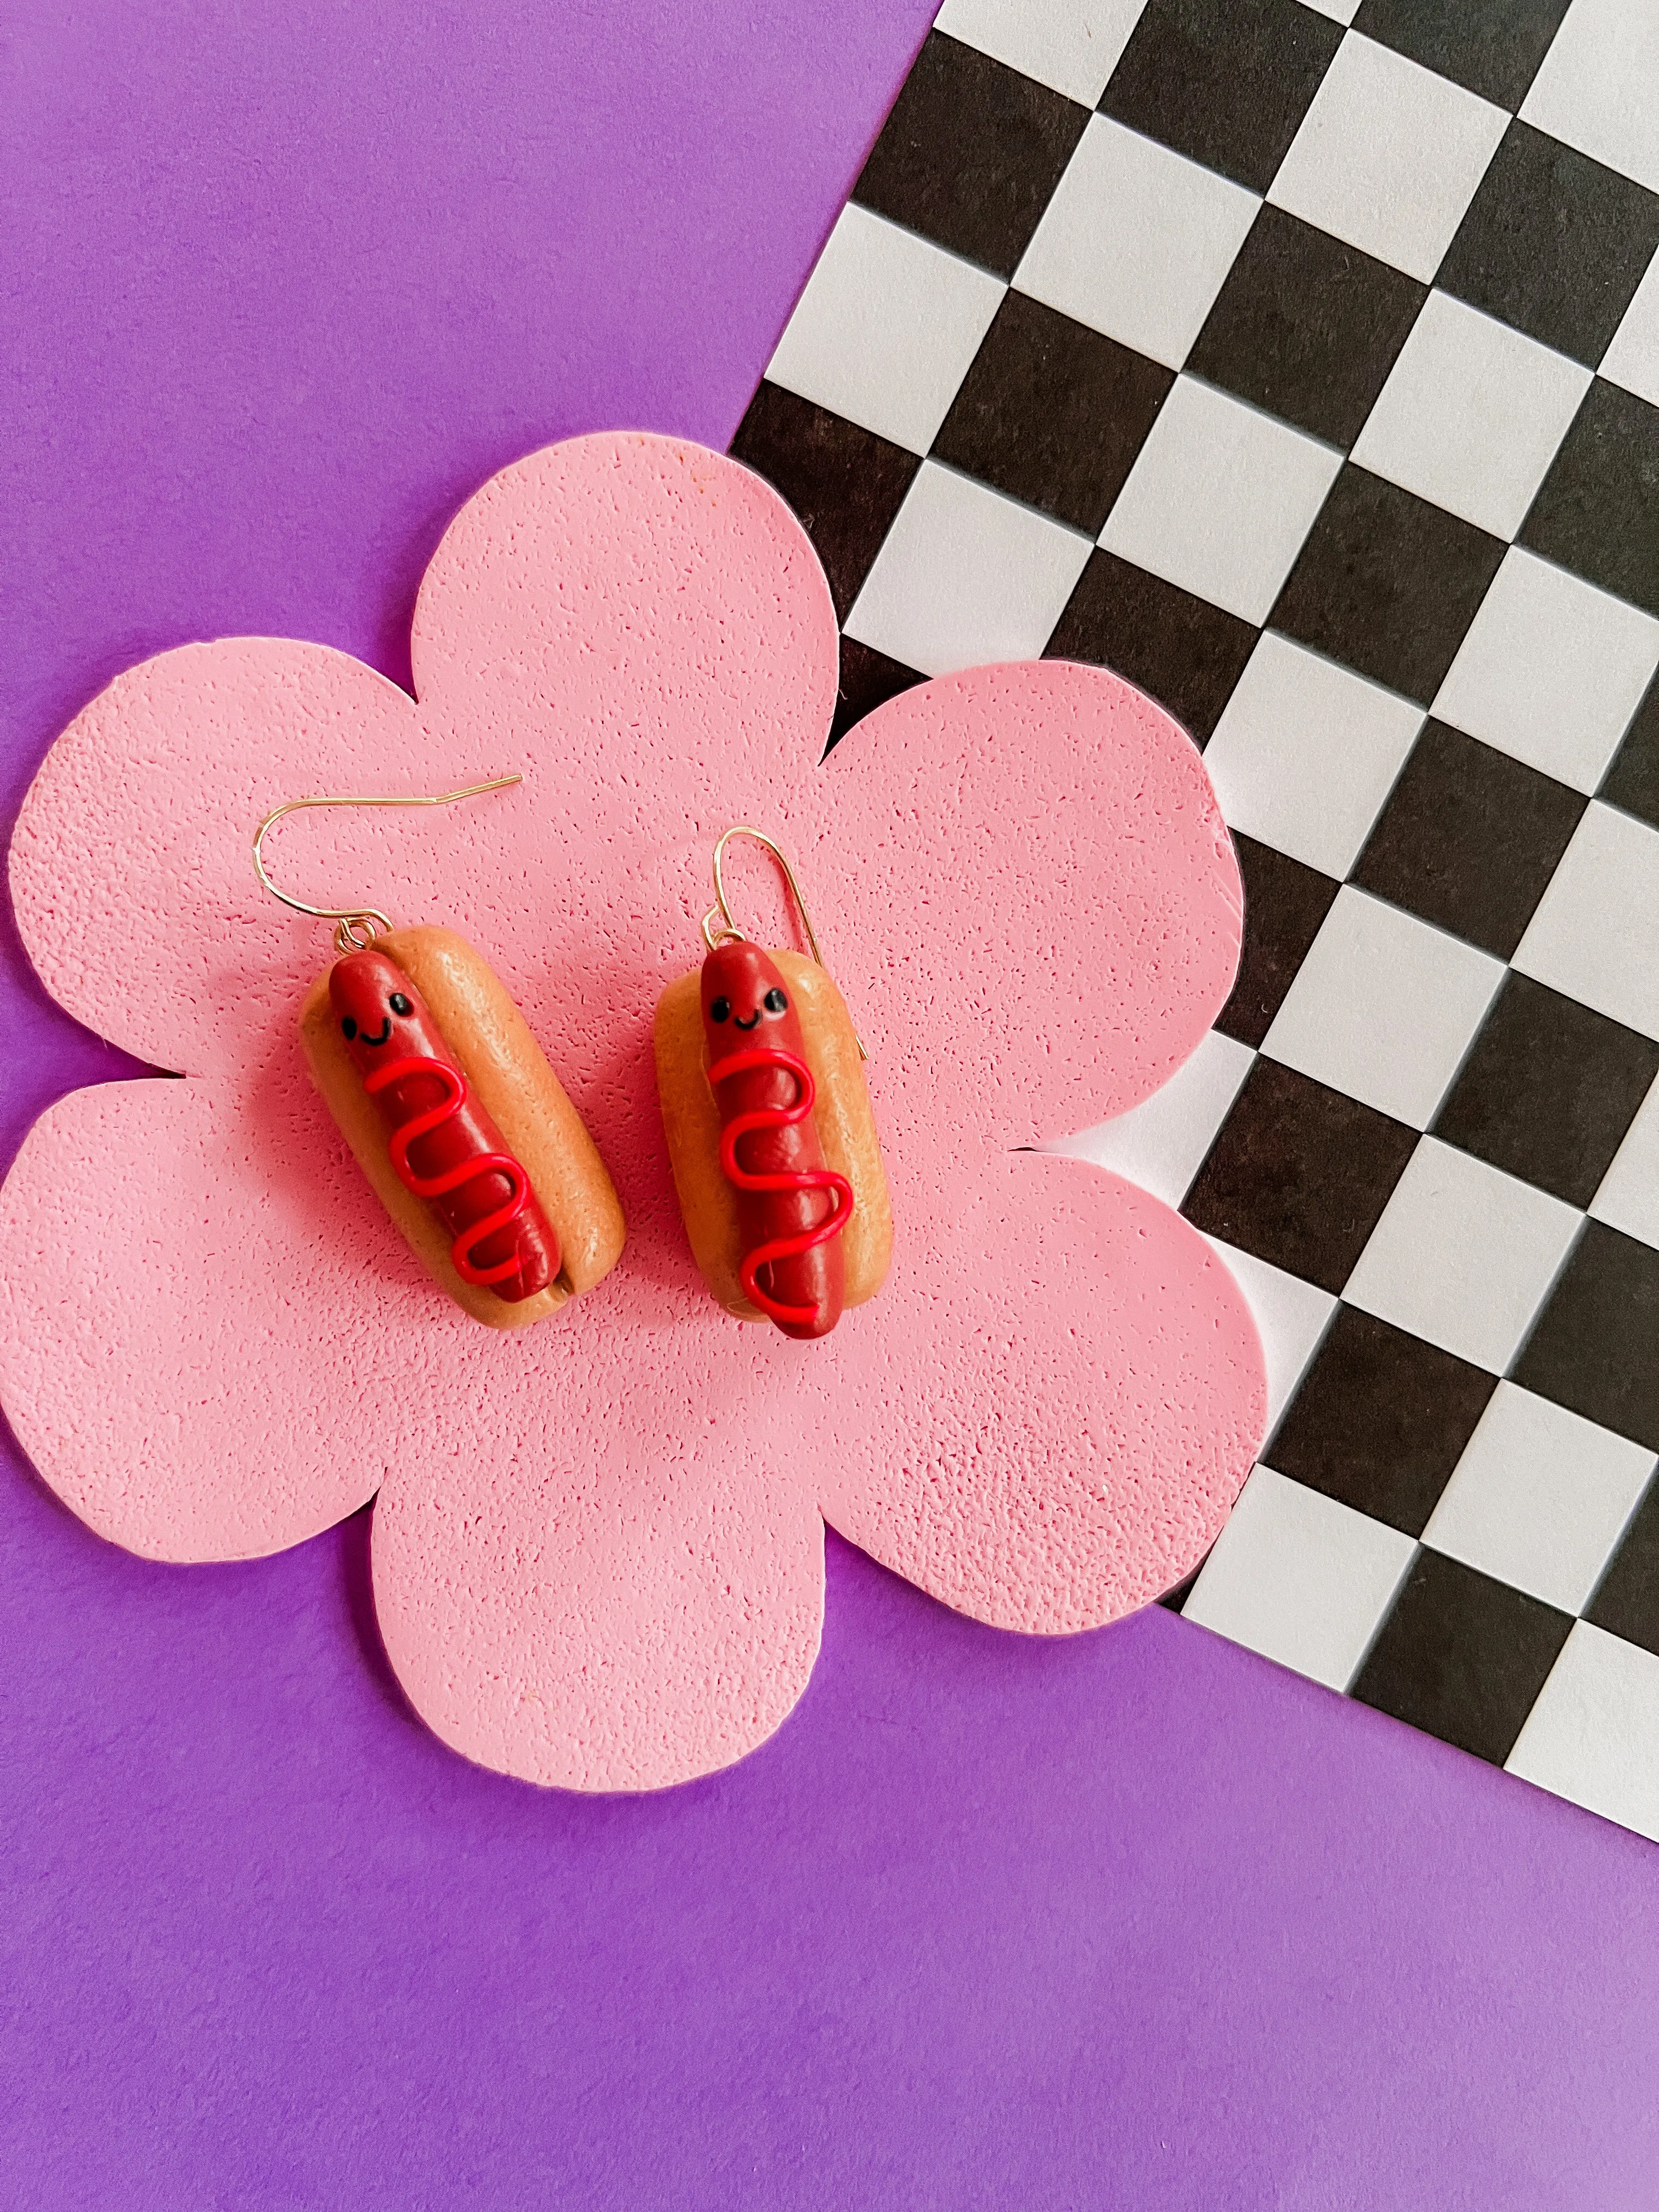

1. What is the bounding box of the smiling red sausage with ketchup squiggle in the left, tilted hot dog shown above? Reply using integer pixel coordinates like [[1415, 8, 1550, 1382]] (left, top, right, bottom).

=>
[[328, 951, 560, 1305]]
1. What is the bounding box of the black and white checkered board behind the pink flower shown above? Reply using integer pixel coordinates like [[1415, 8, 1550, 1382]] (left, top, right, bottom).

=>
[[732, 0, 1659, 1836]]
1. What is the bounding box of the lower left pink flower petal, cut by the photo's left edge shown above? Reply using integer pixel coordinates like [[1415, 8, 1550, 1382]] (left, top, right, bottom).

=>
[[0, 1066, 429, 1560]]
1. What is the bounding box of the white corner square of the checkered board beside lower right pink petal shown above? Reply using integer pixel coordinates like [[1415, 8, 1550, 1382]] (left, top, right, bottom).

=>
[[1181, 1466, 1418, 1690]]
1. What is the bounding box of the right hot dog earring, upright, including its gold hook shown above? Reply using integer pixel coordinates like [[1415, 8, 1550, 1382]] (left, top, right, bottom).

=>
[[654, 827, 894, 1336]]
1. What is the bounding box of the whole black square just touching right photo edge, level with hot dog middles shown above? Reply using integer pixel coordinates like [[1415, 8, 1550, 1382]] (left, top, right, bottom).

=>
[[1434, 973, 1659, 1207]]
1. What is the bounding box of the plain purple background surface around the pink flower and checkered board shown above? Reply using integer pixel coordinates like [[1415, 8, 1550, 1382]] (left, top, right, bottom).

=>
[[0, 0, 1659, 2212]]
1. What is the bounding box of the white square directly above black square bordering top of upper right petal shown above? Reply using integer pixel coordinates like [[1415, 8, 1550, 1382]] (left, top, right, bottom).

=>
[[1099, 376, 1342, 622]]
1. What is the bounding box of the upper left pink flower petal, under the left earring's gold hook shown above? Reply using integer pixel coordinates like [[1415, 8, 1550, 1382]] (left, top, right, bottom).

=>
[[11, 637, 422, 1075]]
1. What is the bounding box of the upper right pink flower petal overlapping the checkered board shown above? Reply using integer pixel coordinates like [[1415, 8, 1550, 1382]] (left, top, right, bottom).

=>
[[822, 662, 1243, 1146]]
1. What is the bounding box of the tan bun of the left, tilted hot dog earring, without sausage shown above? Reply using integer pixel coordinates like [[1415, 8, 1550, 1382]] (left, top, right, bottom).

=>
[[298, 927, 624, 1329]]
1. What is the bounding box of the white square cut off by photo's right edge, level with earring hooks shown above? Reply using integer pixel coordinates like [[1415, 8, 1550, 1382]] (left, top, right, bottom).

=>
[[1513, 799, 1659, 1037]]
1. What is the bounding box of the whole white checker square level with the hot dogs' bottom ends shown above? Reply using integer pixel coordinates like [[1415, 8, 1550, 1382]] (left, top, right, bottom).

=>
[[1342, 1137, 1584, 1376]]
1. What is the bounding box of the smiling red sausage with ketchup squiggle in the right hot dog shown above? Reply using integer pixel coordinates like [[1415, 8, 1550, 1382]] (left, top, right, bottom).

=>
[[703, 940, 851, 1336]]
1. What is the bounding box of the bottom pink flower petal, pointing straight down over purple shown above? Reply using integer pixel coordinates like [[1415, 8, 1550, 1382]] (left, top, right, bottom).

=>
[[374, 1276, 823, 1790]]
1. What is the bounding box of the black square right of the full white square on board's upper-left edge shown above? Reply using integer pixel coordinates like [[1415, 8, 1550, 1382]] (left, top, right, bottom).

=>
[[934, 292, 1175, 538]]
